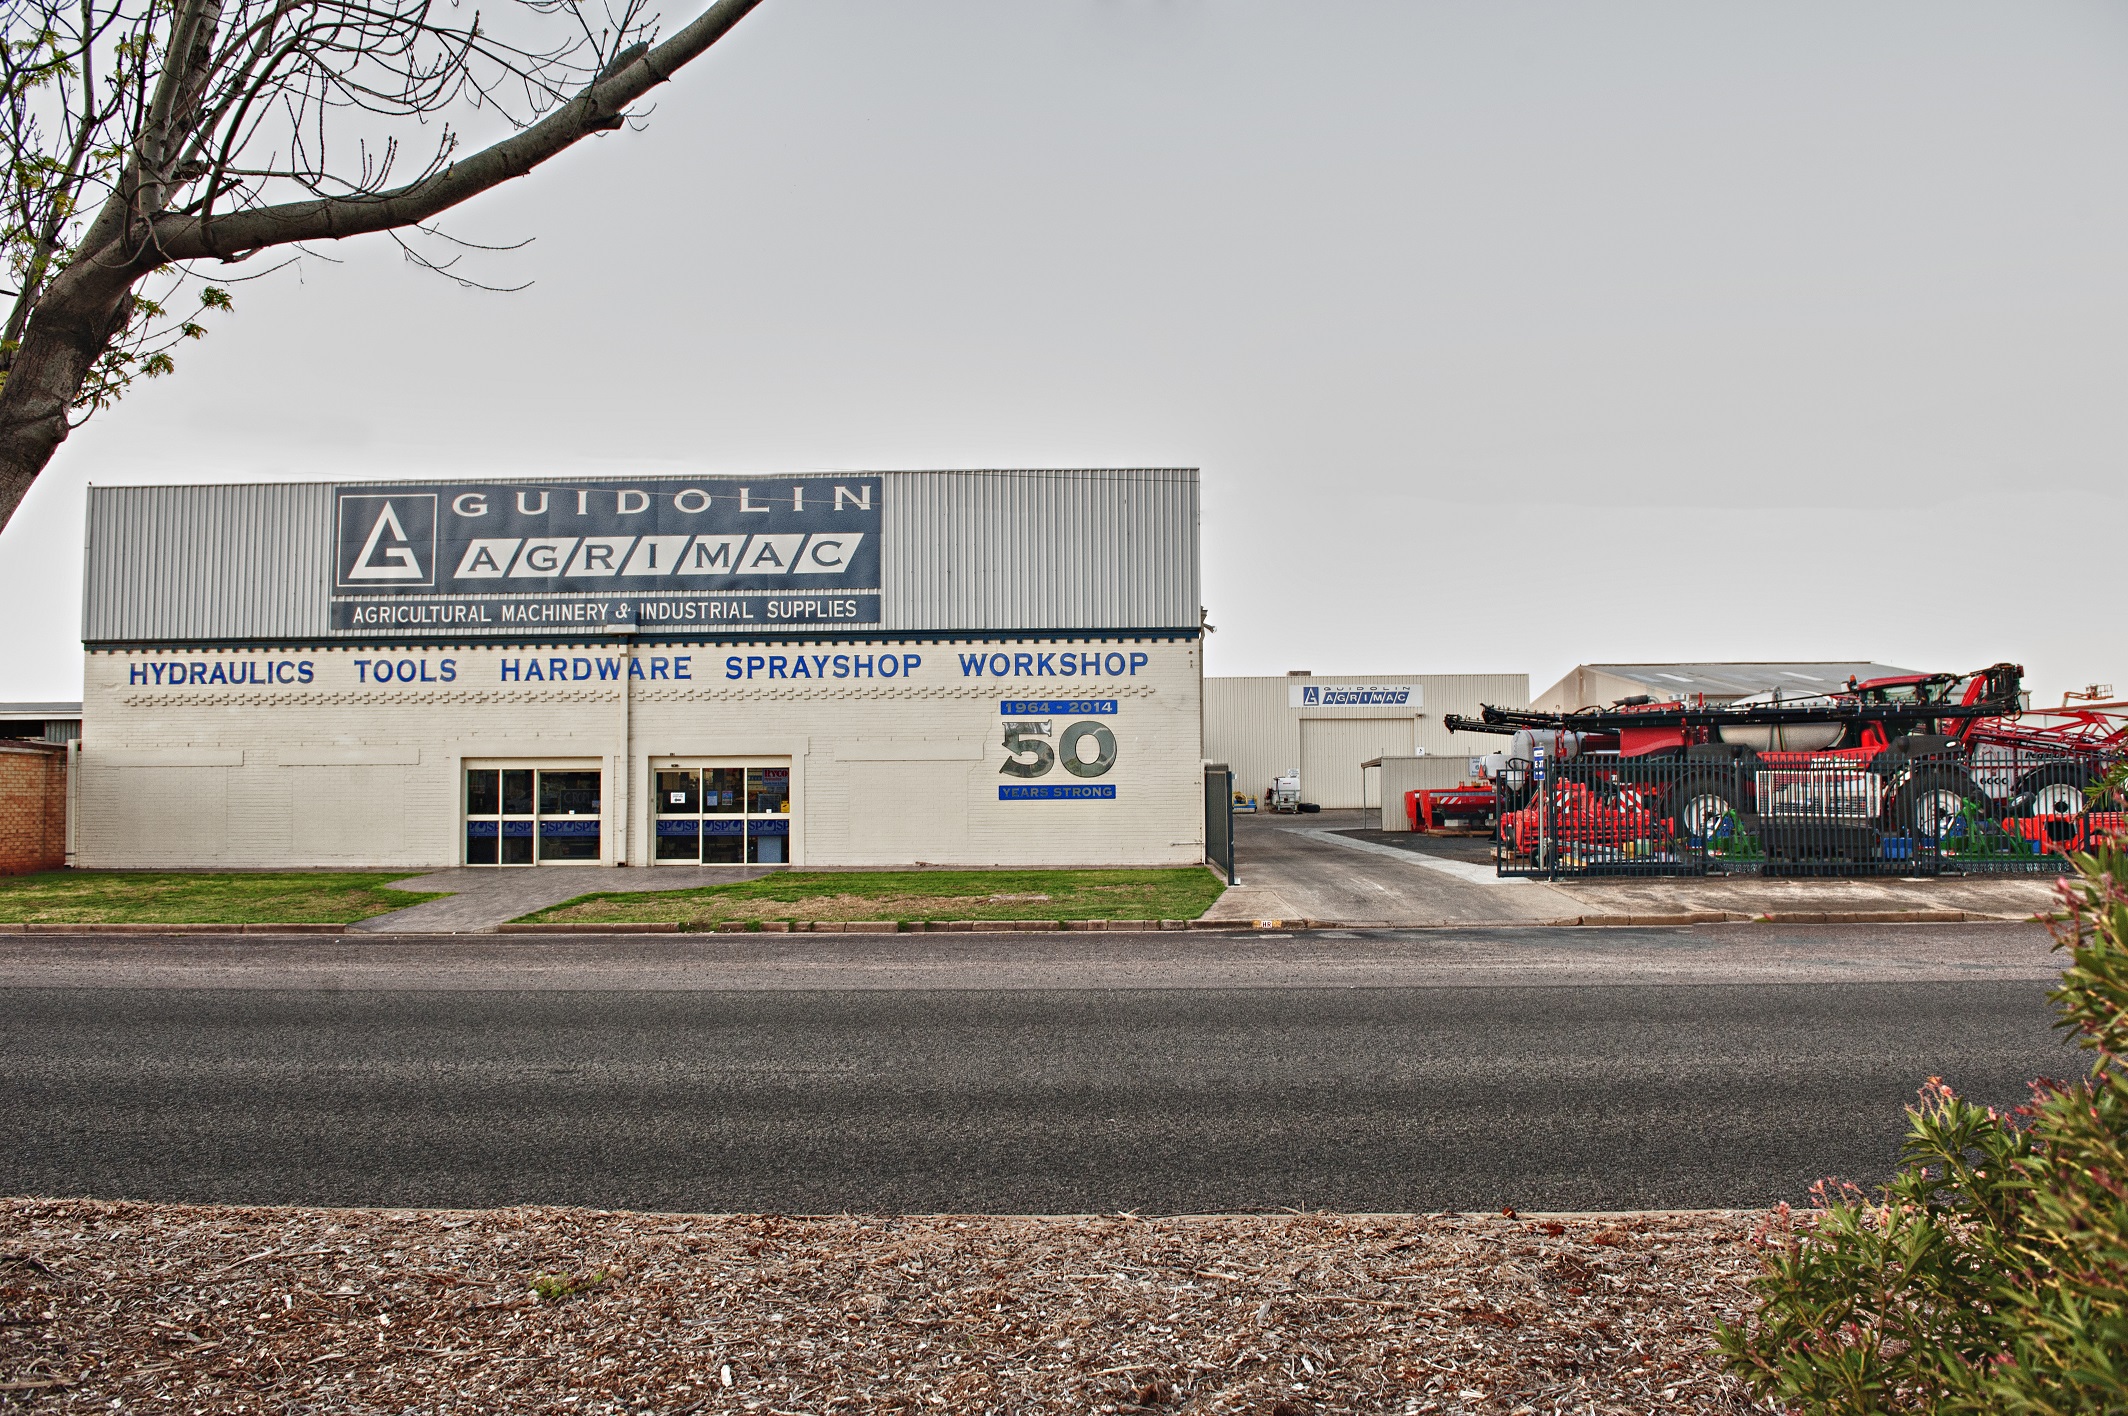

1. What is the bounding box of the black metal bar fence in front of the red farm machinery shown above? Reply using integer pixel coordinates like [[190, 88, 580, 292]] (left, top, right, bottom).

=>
[[1494, 747, 2128, 879]]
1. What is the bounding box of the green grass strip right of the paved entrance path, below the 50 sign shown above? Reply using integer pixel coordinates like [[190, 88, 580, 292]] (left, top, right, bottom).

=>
[[526, 867, 1226, 928]]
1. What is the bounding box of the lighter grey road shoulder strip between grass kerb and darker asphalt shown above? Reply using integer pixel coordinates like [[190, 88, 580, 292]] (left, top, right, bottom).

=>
[[0, 924, 2062, 992]]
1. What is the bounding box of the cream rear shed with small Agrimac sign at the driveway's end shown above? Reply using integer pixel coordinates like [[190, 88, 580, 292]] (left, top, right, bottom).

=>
[[1204, 673, 1530, 809]]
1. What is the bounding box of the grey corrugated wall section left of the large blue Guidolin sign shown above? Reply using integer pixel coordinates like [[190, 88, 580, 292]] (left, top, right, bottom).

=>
[[81, 481, 332, 643]]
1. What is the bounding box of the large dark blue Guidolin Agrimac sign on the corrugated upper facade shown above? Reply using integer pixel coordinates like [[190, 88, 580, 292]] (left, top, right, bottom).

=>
[[332, 477, 883, 635]]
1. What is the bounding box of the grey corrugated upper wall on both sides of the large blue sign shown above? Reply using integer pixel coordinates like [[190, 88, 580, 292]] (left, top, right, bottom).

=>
[[81, 468, 1202, 643]]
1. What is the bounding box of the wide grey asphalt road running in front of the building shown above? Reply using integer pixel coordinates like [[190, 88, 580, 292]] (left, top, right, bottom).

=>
[[0, 926, 2077, 1212]]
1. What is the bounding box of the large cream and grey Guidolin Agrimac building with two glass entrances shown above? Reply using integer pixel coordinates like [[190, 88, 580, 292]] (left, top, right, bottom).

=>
[[74, 468, 1204, 869]]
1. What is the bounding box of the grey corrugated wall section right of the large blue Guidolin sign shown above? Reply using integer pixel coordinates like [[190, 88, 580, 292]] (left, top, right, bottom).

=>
[[881, 468, 1202, 630]]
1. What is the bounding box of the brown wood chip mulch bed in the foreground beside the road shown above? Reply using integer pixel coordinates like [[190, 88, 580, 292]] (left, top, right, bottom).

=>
[[0, 1199, 1760, 1416]]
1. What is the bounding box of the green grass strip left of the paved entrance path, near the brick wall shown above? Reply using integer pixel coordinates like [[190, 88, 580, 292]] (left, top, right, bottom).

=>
[[0, 871, 438, 924]]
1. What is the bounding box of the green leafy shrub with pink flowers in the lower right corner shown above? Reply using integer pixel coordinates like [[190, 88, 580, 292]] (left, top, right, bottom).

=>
[[1719, 771, 2128, 1416]]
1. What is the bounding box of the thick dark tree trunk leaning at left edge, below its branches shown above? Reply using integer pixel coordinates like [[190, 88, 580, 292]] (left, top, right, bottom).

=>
[[0, 251, 151, 528]]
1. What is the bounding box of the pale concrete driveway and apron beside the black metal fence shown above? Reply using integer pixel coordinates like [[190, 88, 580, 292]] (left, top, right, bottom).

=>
[[1204, 811, 2056, 926]]
